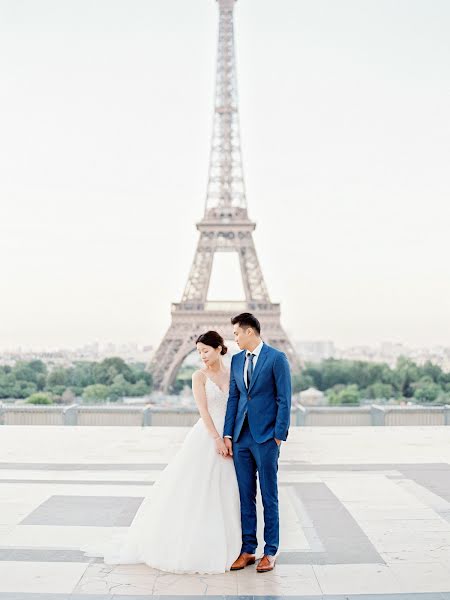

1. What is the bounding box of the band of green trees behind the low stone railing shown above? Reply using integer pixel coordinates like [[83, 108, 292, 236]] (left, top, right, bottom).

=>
[[0, 357, 450, 405]]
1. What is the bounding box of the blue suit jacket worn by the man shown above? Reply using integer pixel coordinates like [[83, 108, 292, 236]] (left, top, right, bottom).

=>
[[223, 344, 291, 444]]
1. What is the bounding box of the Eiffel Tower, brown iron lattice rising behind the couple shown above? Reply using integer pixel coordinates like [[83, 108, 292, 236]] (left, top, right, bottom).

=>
[[150, 0, 298, 392]]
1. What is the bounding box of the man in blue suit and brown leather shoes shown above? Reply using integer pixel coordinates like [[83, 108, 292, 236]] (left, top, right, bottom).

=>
[[223, 313, 291, 573]]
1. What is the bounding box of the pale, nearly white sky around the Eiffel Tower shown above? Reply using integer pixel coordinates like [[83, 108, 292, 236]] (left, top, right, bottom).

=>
[[0, 0, 450, 348]]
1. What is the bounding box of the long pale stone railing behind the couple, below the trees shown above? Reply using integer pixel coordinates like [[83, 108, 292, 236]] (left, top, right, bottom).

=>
[[0, 403, 450, 427]]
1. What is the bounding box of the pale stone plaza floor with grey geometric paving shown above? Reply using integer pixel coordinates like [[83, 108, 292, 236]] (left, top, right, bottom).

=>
[[0, 425, 450, 600]]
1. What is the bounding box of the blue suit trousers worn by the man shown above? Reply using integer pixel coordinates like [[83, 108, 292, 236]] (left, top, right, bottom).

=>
[[233, 415, 280, 556]]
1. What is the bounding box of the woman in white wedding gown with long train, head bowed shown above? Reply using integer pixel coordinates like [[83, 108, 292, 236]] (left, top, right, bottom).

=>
[[81, 331, 241, 573]]
